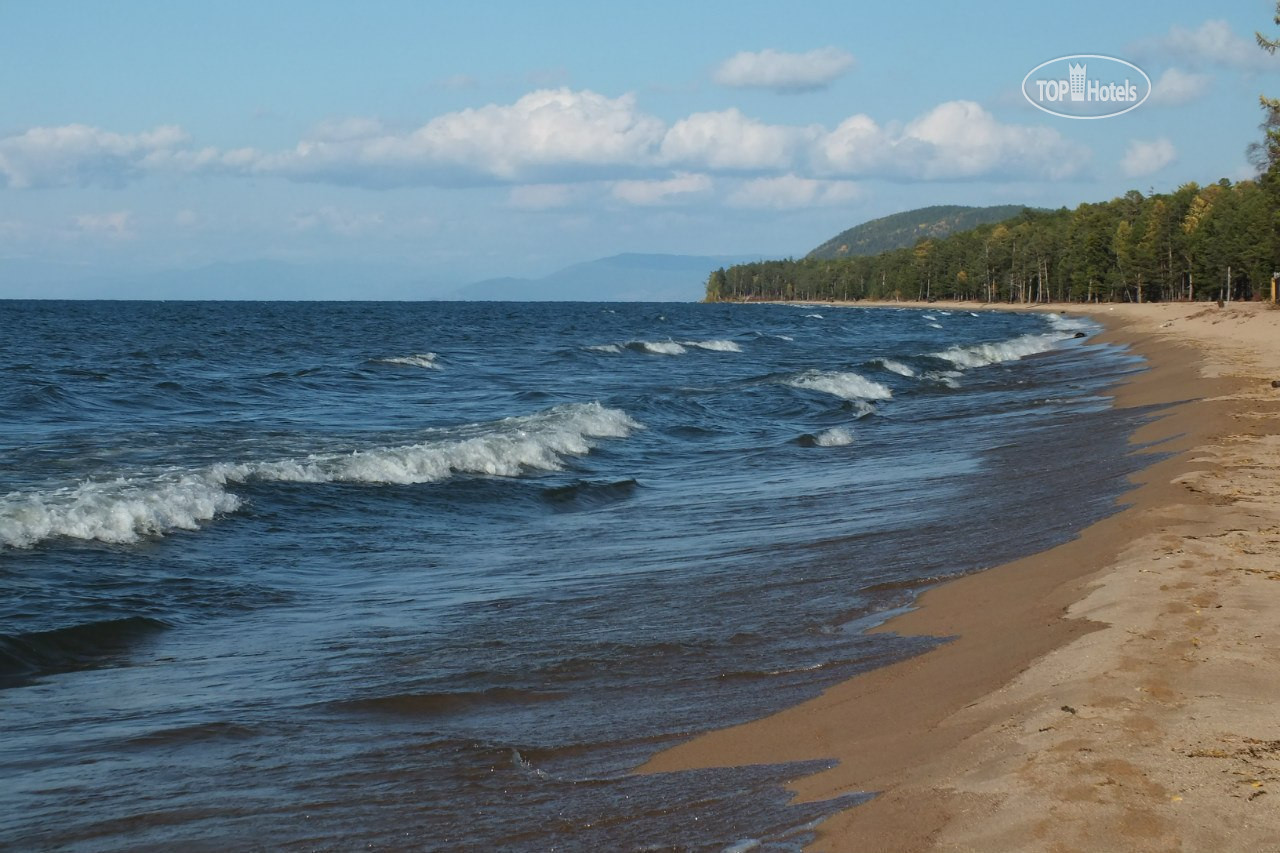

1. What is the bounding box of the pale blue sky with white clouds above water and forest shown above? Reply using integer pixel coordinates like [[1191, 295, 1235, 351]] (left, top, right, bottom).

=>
[[0, 0, 1280, 298]]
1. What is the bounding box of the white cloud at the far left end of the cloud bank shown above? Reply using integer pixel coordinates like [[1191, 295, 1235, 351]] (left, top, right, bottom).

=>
[[0, 124, 187, 190]]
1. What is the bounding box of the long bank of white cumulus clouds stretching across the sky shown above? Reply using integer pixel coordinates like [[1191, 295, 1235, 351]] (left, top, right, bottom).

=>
[[0, 91, 1090, 192]]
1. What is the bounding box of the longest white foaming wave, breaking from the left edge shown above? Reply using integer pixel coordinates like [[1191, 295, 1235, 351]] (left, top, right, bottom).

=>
[[0, 402, 643, 548]]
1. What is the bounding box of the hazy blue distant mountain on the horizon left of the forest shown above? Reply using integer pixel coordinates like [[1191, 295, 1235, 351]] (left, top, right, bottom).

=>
[[445, 252, 759, 302]]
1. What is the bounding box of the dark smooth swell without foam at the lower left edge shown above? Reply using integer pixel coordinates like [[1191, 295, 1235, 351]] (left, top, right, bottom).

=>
[[0, 616, 169, 685]]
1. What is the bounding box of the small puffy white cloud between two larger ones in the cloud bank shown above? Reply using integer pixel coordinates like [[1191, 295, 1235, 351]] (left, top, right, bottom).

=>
[[662, 109, 806, 170]]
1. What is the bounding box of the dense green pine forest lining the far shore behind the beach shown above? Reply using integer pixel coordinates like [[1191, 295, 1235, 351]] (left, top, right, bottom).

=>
[[707, 175, 1280, 302]]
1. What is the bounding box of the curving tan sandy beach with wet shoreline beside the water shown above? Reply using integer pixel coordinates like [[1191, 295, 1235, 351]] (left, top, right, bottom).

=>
[[643, 302, 1280, 852]]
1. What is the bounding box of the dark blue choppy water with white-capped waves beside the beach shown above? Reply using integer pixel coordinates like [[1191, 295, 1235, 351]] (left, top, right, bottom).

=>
[[0, 302, 1142, 850]]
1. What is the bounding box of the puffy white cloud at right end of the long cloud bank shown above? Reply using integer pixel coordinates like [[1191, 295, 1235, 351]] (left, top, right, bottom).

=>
[[813, 101, 1088, 181]]
